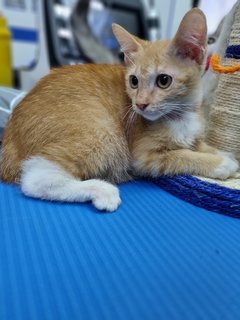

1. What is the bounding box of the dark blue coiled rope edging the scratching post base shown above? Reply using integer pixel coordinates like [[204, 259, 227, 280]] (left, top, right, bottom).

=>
[[152, 176, 240, 218]]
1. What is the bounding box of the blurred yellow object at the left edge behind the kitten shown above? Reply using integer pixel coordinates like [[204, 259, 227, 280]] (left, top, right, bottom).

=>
[[0, 12, 13, 87]]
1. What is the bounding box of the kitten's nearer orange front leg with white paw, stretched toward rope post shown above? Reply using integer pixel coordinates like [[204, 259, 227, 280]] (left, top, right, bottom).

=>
[[133, 149, 239, 179]]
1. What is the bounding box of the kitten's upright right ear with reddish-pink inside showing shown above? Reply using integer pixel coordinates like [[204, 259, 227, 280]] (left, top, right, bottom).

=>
[[169, 8, 207, 65]]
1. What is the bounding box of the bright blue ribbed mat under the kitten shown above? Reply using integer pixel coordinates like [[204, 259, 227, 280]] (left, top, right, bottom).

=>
[[0, 181, 240, 320]]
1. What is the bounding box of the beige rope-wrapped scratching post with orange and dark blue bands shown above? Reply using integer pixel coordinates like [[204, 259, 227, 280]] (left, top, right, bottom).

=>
[[207, 0, 240, 159]]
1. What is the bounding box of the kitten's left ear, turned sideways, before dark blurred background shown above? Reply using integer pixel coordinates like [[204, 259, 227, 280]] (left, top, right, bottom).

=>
[[112, 23, 144, 64]]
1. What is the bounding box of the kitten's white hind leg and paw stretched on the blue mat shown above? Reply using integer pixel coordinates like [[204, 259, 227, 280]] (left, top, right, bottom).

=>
[[21, 156, 121, 212]]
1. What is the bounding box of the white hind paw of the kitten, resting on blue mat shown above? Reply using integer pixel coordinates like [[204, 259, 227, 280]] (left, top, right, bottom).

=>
[[92, 182, 121, 212]]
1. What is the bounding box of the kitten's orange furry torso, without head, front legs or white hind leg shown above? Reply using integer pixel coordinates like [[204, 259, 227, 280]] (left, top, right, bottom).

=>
[[1, 65, 129, 182]]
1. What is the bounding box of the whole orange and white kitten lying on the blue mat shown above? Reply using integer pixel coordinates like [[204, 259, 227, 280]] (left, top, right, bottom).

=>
[[1, 9, 238, 212]]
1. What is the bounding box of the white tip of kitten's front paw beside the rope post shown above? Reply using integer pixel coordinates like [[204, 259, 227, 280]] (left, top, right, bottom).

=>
[[213, 152, 239, 180]]
